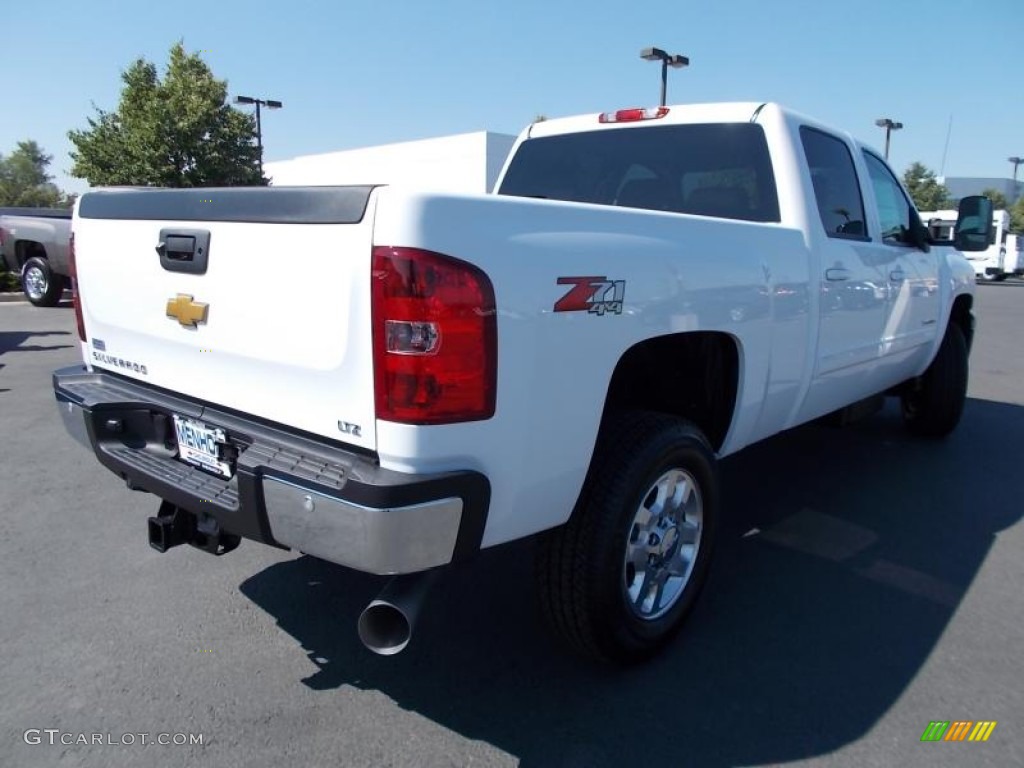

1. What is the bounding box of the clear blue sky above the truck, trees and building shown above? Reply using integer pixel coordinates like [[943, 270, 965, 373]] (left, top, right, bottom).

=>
[[0, 0, 1024, 191]]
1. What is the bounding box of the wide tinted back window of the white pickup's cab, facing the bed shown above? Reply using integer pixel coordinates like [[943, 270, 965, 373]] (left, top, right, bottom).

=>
[[498, 123, 779, 221]]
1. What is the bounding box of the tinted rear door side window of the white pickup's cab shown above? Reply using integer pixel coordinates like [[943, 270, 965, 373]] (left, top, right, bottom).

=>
[[800, 126, 867, 240]]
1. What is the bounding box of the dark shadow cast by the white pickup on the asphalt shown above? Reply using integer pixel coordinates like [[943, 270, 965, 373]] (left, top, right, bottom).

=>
[[241, 399, 1024, 766]]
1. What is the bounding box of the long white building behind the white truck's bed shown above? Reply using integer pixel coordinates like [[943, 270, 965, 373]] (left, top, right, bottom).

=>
[[263, 131, 516, 193]]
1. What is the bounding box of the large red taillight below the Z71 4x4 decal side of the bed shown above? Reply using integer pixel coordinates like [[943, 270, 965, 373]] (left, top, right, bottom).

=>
[[372, 246, 498, 424]]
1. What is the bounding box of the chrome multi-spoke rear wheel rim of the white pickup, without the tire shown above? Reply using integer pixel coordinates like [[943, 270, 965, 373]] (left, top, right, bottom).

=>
[[623, 469, 703, 621]]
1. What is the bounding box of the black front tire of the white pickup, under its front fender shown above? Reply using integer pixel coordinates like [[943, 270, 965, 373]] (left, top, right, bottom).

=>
[[902, 323, 969, 437]]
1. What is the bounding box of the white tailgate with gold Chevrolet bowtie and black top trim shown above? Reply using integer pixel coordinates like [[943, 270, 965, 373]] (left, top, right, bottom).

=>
[[74, 186, 376, 450]]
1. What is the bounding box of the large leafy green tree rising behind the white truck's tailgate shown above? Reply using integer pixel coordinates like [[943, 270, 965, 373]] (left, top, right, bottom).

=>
[[68, 42, 267, 186]]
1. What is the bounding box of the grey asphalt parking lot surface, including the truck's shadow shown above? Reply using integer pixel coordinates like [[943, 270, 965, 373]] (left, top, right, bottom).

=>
[[0, 281, 1024, 768]]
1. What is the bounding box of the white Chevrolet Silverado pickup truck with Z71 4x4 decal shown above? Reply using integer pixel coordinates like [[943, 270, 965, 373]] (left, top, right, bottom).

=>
[[53, 103, 992, 663]]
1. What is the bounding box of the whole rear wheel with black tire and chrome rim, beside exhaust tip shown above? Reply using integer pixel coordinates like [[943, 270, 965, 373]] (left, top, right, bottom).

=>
[[536, 412, 719, 664]]
